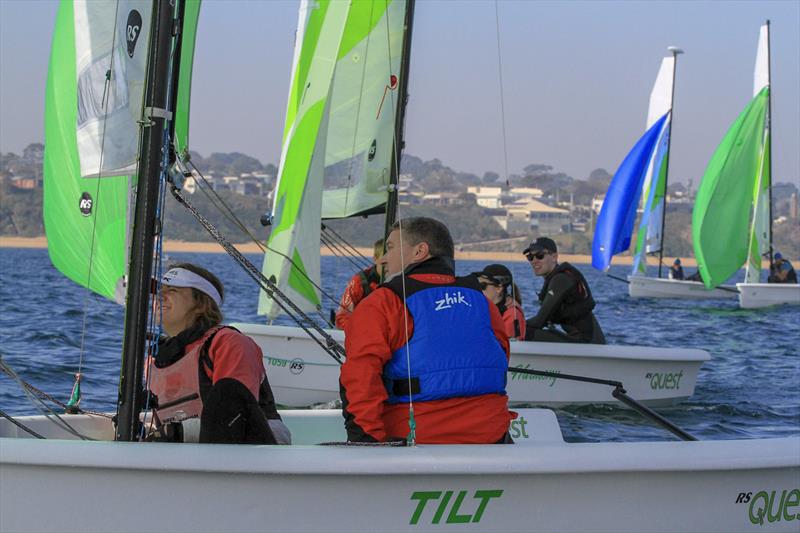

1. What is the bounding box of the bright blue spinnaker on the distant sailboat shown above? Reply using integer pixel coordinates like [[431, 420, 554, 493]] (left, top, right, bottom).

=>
[[592, 113, 668, 270]]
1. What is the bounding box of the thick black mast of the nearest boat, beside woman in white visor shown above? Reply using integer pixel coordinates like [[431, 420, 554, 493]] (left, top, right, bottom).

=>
[[115, 0, 180, 441]]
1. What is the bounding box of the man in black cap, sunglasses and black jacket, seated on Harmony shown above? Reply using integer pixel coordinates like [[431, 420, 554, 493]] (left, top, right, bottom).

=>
[[522, 237, 606, 344]]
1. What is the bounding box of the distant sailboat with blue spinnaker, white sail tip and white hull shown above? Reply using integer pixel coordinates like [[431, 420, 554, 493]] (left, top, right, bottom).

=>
[[592, 46, 736, 299]]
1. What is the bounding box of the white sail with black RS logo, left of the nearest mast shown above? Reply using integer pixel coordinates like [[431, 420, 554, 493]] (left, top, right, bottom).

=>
[[74, 0, 153, 177]]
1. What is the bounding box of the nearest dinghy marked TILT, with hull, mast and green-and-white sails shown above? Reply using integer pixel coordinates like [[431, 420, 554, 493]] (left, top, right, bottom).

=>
[[0, 4, 800, 532]]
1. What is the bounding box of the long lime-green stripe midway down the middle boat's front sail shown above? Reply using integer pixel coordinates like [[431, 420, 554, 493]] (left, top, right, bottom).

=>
[[269, 100, 325, 239]]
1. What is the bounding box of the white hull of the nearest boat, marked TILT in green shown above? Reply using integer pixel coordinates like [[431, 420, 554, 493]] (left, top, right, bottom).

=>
[[0, 410, 800, 533]]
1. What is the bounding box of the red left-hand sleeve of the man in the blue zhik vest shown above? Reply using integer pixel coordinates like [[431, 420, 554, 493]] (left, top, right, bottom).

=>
[[340, 288, 413, 441]]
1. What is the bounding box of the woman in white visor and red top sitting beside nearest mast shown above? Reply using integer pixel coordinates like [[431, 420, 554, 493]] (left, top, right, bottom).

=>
[[148, 263, 291, 444]]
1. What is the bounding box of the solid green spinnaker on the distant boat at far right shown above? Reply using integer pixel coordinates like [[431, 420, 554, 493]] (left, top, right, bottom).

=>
[[692, 87, 769, 288]]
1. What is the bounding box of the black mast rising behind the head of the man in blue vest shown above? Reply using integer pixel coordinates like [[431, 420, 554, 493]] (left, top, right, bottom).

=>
[[383, 0, 416, 241]]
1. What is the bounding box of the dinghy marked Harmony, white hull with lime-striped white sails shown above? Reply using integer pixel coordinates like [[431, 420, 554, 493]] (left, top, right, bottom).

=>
[[247, 1, 709, 407]]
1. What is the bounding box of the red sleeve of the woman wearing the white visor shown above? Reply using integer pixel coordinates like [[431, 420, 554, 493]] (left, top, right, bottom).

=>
[[208, 328, 266, 399]]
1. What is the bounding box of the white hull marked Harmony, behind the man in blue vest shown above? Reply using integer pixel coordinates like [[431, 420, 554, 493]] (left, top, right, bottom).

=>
[[232, 324, 710, 407]]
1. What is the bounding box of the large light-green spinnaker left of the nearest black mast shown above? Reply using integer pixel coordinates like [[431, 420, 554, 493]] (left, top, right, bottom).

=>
[[44, 0, 129, 299]]
